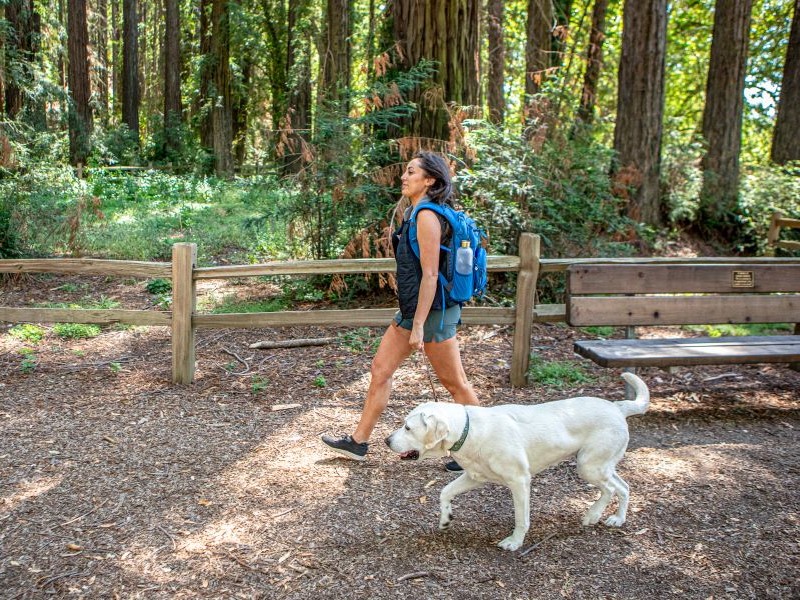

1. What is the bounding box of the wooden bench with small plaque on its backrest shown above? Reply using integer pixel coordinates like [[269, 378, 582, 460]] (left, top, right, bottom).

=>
[[566, 263, 800, 367]]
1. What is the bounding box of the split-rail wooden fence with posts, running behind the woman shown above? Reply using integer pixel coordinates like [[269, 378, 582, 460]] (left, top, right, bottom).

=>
[[0, 233, 800, 386]]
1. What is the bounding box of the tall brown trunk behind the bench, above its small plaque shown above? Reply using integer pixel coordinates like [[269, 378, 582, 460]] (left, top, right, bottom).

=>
[[700, 0, 752, 235]]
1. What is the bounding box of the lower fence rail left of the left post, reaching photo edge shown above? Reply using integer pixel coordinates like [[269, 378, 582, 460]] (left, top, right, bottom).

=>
[[0, 306, 172, 326]]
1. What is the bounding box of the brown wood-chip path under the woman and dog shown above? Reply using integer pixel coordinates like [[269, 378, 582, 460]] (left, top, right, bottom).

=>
[[0, 276, 800, 599]]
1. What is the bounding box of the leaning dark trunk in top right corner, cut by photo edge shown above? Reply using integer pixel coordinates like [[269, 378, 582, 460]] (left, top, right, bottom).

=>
[[772, 0, 800, 164]]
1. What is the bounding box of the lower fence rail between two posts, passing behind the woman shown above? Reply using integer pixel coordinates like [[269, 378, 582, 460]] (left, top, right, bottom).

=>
[[193, 306, 514, 329]]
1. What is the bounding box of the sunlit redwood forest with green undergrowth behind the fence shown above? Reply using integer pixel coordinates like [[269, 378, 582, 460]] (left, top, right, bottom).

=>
[[0, 0, 800, 296]]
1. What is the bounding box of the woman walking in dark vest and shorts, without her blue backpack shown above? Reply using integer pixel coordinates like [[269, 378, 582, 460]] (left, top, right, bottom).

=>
[[322, 152, 478, 471]]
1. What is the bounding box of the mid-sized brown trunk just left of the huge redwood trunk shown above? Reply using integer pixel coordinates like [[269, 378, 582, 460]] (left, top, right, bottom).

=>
[[317, 0, 353, 110]]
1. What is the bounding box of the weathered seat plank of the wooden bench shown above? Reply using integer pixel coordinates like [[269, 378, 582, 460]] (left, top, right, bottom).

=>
[[574, 335, 800, 367]]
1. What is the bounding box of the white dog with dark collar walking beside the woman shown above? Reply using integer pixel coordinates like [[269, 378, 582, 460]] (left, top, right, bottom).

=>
[[386, 373, 650, 550]]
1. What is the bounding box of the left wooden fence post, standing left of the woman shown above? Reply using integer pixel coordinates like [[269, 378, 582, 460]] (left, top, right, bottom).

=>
[[172, 244, 197, 383]]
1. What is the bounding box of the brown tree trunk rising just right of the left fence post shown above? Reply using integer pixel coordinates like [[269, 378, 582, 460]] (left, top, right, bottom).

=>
[[211, 0, 233, 176]]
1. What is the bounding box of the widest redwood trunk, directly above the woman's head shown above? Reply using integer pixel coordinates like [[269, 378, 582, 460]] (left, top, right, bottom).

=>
[[392, 0, 480, 140]]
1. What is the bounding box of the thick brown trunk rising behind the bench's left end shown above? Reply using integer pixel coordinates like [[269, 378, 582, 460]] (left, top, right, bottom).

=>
[[612, 0, 667, 225]]
